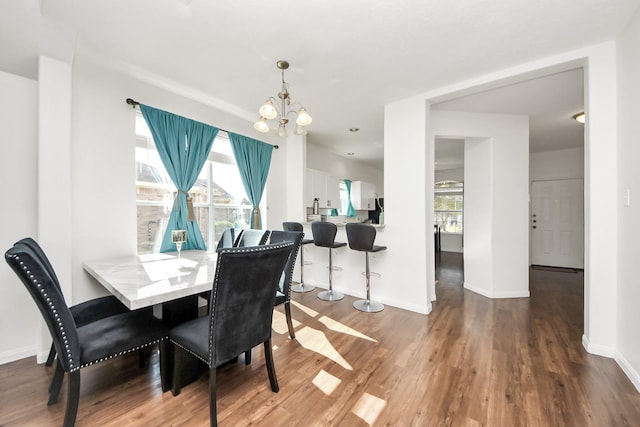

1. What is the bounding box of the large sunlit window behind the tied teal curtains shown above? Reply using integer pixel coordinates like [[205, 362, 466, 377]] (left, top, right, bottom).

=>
[[136, 114, 252, 253]]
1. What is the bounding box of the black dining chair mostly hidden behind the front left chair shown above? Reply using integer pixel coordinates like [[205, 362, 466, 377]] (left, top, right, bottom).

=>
[[16, 237, 129, 404]]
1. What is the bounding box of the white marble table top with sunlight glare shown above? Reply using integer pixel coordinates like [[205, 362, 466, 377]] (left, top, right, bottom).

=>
[[82, 250, 217, 310]]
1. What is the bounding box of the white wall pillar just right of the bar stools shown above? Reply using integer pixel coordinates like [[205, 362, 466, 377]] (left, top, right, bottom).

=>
[[384, 97, 435, 313]]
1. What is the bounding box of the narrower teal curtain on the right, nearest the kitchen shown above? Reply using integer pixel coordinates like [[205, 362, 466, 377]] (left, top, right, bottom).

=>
[[229, 132, 273, 229]]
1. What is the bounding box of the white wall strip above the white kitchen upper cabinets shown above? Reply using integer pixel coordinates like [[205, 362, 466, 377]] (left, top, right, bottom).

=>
[[307, 143, 384, 194]]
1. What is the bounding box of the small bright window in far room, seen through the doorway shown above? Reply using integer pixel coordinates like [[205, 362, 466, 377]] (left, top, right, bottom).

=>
[[433, 181, 464, 233]]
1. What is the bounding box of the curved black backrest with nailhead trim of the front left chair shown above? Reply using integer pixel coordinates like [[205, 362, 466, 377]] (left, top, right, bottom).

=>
[[4, 242, 81, 372]]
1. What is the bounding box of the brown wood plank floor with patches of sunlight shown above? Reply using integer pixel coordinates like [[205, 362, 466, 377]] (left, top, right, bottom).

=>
[[0, 252, 640, 427]]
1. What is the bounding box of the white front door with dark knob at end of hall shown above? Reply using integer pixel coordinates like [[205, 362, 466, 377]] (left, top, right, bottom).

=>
[[529, 179, 584, 268]]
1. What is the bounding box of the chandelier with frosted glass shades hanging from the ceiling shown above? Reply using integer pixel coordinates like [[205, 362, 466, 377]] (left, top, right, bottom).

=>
[[253, 60, 313, 136]]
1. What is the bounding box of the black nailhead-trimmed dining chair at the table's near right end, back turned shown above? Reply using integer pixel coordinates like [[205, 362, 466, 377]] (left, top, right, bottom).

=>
[[169, 242, 293, 426]]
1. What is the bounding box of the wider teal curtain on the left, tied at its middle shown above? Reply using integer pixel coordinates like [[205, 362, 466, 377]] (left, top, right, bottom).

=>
[[140, 104, 218, 252]]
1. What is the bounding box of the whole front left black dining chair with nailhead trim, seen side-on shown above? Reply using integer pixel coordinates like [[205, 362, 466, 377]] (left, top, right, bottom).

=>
[[5, 242, 169, 427]]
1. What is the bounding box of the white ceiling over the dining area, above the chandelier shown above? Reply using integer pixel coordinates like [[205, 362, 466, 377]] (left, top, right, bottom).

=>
[[0, 0, 640, 171]]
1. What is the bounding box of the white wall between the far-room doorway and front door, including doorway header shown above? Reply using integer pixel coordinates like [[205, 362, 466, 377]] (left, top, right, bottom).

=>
[[429, 110, 529, 298]]
